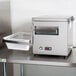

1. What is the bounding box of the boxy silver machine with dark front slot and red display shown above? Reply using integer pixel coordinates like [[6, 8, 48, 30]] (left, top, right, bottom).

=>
[[32, 16, 74, 56]]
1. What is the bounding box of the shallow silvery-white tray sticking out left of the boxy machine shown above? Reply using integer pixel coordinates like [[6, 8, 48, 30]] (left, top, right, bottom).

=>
[[3, 32, 31, 51]]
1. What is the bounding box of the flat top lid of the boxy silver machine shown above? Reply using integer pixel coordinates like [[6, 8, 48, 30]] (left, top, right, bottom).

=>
[[32, 15, 74, 22]]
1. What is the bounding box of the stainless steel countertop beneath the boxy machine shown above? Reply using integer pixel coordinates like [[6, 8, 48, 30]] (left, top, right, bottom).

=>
[[0, 48, 76, 67]]
